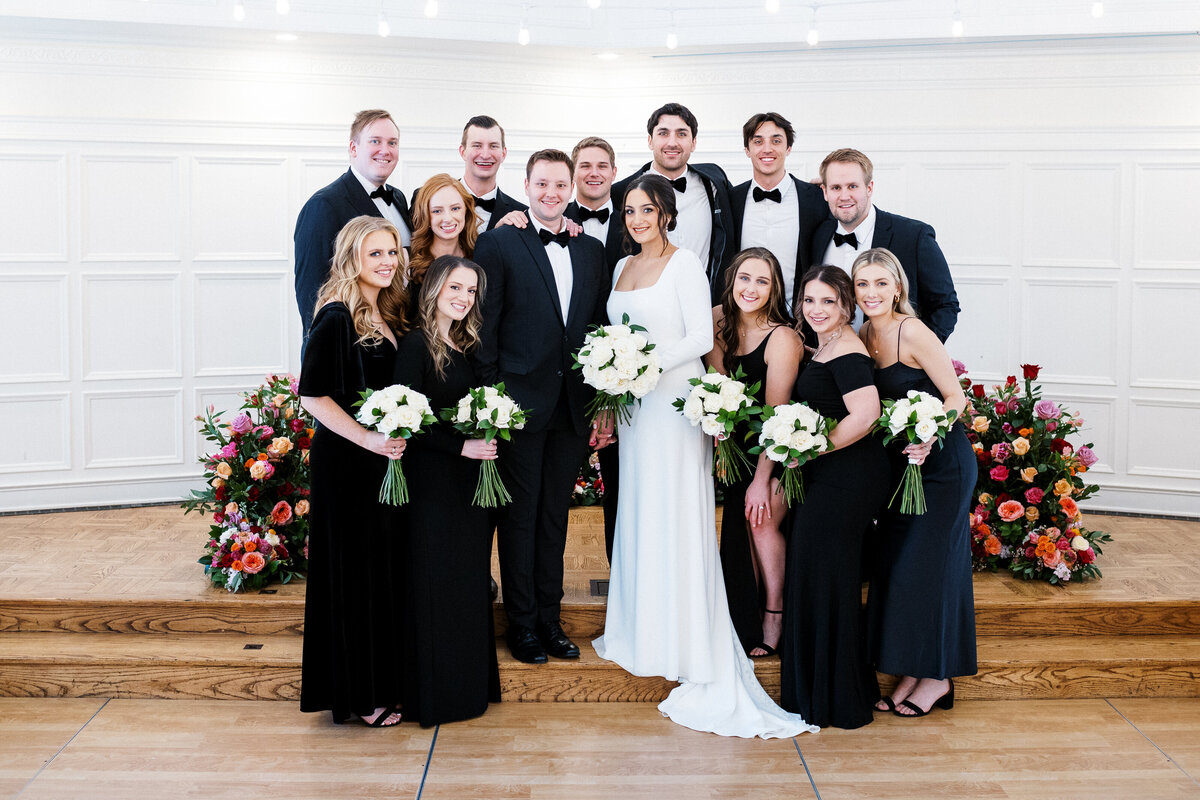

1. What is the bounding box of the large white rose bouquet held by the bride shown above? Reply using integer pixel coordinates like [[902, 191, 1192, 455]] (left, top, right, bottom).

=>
[[574, 314, 662, 422]]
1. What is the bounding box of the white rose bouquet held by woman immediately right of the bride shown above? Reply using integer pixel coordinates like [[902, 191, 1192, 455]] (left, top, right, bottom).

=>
[[672, 367, 762, 485]]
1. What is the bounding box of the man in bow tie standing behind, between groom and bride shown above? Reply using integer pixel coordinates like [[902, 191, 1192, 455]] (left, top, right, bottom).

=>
[[566, 136, 625, 561]]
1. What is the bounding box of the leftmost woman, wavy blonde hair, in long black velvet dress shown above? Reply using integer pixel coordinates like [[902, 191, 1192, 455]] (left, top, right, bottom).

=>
[[300, 216, 408, 727]]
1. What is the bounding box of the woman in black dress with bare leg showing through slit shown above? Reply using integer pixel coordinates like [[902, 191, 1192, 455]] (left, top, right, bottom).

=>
[[706, 247, 803, 657]]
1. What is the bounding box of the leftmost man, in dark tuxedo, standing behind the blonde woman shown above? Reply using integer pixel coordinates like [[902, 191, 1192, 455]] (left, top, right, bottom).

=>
[[294, 108, 413, 337]]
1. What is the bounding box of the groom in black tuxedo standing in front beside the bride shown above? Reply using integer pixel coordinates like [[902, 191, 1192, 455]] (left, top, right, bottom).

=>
[[472, 150, 611, 663]]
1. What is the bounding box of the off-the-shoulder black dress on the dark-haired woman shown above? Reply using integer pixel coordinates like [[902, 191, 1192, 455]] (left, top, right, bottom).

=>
[[780, 353, 889, 728]]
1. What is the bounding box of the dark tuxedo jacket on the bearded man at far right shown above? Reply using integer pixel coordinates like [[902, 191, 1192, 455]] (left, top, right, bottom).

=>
[[811, 207, 959, 342]]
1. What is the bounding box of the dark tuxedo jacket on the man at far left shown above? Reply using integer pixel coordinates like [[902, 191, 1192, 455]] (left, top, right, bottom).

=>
[[293, 169, 413, 337]]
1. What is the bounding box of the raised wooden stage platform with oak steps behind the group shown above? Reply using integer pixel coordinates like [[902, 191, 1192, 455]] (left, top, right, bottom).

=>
[[0, 506, 1200, 702]]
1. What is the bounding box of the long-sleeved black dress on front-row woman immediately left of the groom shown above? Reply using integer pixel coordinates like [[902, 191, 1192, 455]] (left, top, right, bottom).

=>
[[396, 331, 500, 727]]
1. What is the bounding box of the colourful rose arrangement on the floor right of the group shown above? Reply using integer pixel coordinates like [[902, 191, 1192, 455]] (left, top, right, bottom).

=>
[[954, 361, 1112, 584]]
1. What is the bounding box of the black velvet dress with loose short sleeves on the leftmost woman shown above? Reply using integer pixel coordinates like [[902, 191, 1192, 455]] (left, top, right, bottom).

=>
[[300, 302, 404, 722]]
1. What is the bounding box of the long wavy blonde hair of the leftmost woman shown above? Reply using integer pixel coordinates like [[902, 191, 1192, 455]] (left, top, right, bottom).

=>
[[314, 216, 408, 345]]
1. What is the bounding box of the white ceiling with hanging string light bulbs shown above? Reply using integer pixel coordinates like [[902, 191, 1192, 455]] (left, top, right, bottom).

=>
[[0, 0, 1200, 55]]
